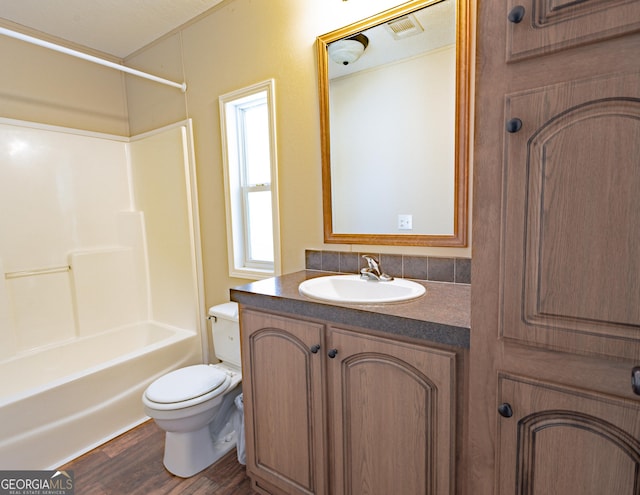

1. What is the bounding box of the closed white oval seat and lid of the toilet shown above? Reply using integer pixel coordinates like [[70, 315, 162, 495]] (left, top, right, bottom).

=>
[[144, 364, 231, 410]]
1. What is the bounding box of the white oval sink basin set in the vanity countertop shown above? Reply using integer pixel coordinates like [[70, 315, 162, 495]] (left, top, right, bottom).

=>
[[299, 275, 425, 304]]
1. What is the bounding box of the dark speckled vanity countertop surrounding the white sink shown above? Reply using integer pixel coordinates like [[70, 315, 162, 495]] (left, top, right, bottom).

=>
[[231, 270, 471, 348]]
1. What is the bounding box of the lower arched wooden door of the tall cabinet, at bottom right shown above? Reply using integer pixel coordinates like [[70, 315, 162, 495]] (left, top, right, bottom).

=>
[[498, 375, 640, 495]]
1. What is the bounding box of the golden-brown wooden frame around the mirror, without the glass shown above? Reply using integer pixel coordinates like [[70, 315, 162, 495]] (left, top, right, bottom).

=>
[[316, 0, 473, 247]]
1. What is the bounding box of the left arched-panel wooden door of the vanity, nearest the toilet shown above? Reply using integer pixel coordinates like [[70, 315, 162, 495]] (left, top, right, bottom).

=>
[[241, 310, 327, 494]]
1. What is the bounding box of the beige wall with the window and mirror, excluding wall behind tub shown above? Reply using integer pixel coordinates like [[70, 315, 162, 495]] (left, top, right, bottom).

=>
[[127, 0, 471, 305]]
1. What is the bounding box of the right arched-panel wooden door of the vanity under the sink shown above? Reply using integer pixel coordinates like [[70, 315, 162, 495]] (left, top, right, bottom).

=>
[[327, 328, 455, 495]]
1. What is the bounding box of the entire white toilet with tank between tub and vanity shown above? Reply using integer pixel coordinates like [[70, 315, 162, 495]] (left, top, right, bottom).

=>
[[142, 302, 242, 478]]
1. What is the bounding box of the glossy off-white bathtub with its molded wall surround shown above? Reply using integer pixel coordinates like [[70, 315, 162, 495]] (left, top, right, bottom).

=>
[[0, 119, 206, 469]]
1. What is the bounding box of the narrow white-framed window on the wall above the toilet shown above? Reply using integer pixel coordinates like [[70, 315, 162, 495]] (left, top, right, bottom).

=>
[[220, 79, 280, 279]]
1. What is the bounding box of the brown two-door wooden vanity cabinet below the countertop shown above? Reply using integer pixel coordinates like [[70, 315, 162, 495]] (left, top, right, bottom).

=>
[[240, 308, 457, 495]]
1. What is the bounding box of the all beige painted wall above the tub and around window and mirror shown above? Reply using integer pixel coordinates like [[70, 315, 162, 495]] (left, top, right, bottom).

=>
[[0, 0, 471, 314]]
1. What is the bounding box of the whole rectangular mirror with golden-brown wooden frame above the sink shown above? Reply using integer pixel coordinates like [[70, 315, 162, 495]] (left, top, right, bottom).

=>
[[316, 0, 471, 247]]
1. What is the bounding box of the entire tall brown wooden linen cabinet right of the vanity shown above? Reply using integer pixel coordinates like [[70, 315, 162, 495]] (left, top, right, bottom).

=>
[[467, 0, 640, 495]]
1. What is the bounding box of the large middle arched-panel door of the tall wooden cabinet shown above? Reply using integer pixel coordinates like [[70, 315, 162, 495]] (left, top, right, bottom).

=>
[[501, 74, 640, 358]]
